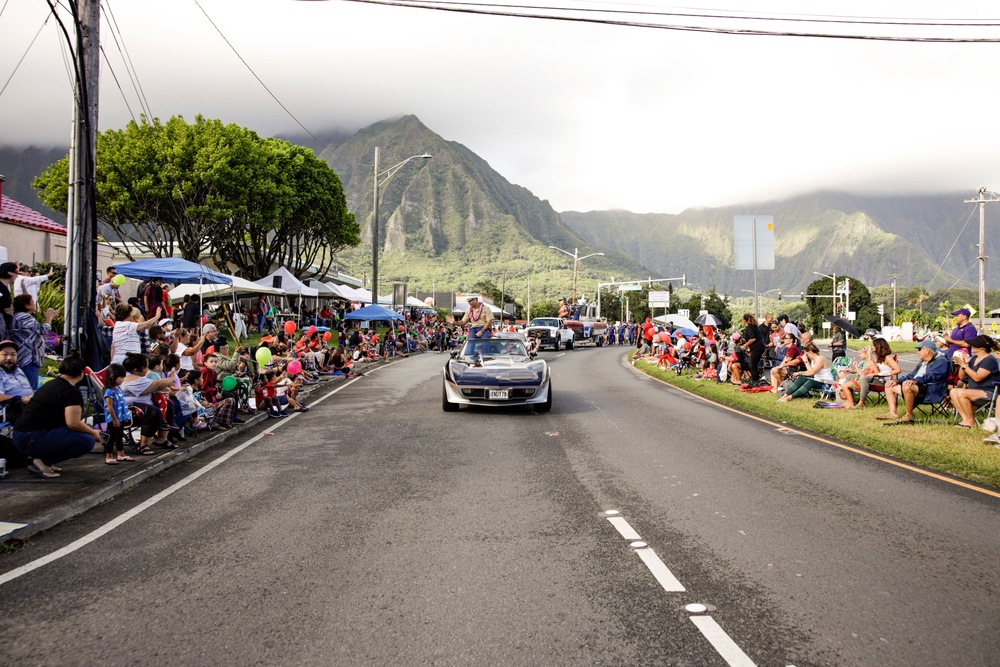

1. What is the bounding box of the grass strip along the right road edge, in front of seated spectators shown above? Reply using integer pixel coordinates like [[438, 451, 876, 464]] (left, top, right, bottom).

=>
[[635, 354, 1000, 489]]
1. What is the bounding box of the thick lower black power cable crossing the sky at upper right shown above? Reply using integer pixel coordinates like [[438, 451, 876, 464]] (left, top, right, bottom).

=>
[[341, 0, 1000, 44]]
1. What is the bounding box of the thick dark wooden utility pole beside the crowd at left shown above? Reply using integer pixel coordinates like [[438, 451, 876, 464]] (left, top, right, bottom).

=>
[[61, 0, 101, 361]]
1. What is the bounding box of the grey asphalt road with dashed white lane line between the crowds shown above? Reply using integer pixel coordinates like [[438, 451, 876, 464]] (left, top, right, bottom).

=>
[[0, 348, 1000, 667]]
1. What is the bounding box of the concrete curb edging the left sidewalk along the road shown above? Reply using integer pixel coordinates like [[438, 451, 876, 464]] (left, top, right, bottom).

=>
[[0, 361, 393, 544]]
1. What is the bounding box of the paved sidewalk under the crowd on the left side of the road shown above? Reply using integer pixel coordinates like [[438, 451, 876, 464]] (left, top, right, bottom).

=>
[[0, 362, 382, 543]]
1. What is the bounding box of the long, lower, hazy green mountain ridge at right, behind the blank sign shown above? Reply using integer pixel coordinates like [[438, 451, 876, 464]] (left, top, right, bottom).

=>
[[560, 192, 984, 295]]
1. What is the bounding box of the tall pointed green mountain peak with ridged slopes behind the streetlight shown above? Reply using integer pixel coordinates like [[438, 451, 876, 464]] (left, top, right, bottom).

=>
[[321, 116, 648, 299]]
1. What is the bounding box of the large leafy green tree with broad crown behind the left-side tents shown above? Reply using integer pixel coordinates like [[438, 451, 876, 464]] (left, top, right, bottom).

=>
[[33, 116, 360, 279]]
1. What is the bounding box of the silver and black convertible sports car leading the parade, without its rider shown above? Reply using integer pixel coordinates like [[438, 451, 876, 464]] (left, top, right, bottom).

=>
[[441, 334, 552, 412]]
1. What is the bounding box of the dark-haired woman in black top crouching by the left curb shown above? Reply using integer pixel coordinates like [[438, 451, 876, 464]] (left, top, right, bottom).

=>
[[12, 353, 102, 479]]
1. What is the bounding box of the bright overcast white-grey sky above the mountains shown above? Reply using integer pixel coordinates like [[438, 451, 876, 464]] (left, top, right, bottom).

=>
[[0, 0, 1000, 213]]
